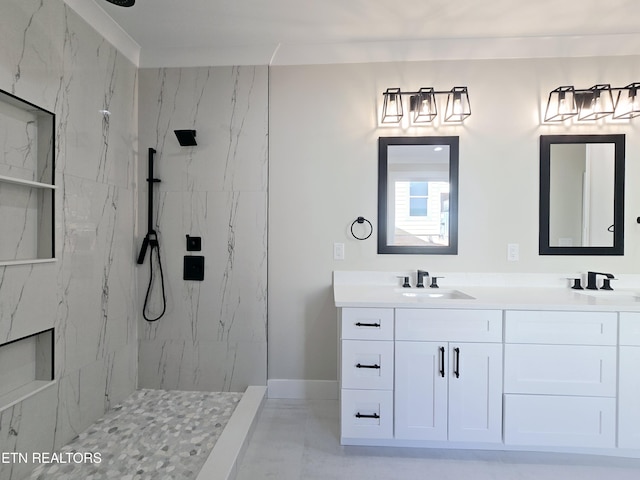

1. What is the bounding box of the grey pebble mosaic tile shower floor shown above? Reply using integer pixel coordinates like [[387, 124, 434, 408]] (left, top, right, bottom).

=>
[[30, 390, 242, 480]]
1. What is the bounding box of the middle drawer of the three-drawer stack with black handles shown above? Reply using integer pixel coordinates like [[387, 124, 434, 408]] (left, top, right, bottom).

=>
[[341, 340, 393, 390]]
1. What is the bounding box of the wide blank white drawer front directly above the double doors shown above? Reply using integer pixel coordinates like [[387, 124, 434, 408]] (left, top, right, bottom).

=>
[[396, 308, 502, 342]]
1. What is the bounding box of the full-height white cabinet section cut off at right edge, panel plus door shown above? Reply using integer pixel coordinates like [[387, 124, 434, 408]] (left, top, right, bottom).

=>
[[618, 312, 640, 449]]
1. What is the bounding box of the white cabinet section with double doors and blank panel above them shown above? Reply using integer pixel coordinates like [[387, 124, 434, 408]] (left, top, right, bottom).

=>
[[394, 309, 502, 442]]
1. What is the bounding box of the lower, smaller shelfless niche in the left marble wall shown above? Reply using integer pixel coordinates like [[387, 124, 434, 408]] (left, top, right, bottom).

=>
[[0, 328, 55, 412]]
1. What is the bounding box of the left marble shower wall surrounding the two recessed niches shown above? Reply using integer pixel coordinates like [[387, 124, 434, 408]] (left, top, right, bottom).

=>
[[0, 0, 139, 480]]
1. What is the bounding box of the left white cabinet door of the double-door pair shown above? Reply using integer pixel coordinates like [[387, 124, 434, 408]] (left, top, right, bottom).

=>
[[394, 342, 449, 440]]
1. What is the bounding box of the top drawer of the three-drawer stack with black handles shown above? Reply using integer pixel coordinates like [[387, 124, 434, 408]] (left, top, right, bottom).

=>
[[341, 308, 393, 340]]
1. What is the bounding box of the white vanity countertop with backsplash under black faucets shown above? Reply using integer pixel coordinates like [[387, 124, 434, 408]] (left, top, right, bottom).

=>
[[333, 272, 640, 312]]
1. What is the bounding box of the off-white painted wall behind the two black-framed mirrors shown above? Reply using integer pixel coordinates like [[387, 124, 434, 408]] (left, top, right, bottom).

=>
[[269, 57, 640, 380]]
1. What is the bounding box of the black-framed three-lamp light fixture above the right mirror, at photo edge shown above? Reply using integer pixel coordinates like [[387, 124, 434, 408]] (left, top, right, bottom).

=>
[[544, 83, 640, 122]]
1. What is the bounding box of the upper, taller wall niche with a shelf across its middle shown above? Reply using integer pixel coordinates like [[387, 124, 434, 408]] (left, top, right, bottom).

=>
[[0, 90, 56, 266]]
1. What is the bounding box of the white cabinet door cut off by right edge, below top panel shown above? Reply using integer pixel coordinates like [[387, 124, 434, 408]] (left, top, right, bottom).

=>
[[618, 347, 640, 448]]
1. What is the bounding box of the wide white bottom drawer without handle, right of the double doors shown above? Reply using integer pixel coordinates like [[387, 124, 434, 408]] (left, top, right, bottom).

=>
[[504, 395, 616, 448]]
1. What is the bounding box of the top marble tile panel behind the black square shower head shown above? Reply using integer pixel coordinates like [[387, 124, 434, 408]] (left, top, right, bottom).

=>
[[139, 66, 268, 191]]
